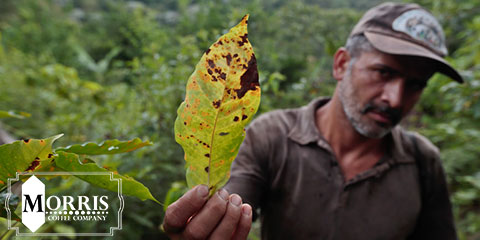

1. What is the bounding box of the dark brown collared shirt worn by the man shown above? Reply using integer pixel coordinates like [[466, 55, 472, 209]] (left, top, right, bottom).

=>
[[226, 98, 456, 240]]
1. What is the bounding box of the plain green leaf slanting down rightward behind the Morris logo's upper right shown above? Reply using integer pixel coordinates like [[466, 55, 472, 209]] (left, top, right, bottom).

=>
[[55, 152, 159, 203]]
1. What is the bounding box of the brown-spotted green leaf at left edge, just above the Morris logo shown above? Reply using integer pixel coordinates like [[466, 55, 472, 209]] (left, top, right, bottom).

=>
[[0, 134, 63, 189]]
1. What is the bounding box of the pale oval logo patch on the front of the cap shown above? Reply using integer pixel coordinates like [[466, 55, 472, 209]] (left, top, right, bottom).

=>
[[392, 9, 447, 55]]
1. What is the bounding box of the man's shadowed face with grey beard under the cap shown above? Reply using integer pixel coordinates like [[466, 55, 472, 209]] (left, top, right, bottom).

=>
[[339, 50, 434, 138]]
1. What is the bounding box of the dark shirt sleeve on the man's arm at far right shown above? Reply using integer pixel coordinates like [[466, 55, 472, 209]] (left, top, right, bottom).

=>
[[408, 134, 458, 240]]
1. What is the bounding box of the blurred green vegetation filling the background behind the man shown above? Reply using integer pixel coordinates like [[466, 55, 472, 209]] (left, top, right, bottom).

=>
[[0, 0, 480, 240]]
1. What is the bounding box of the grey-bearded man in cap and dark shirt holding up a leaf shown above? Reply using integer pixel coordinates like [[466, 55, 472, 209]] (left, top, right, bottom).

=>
[[163, 3, 463, 240]]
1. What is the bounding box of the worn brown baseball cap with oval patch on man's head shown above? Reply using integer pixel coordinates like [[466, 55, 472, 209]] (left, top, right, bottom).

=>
[[350, 2, 463, 83]]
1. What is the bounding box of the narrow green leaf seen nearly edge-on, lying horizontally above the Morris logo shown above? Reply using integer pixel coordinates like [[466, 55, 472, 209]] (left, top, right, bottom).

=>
[[55, 138, 152, 155]]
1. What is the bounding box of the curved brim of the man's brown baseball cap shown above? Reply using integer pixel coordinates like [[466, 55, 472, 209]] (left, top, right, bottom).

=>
[[364, 32, 463, 83]]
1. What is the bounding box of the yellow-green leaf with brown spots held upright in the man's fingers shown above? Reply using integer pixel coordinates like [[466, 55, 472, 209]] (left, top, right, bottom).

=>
[[175, 15, 260, 194]]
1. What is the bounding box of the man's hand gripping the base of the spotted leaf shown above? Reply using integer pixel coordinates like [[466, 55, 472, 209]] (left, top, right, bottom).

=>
[[163, 185, 252, 240]]
